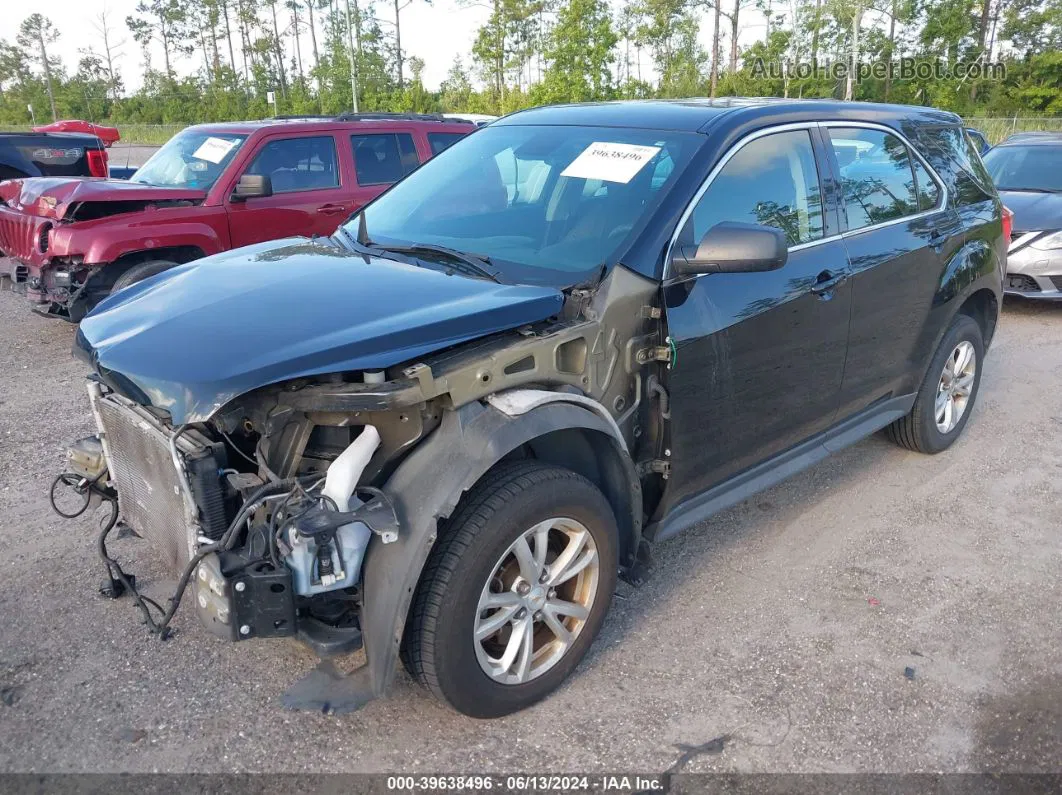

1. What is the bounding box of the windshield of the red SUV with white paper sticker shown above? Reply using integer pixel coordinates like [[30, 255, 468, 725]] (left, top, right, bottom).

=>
[[130, 129, 246, 190]]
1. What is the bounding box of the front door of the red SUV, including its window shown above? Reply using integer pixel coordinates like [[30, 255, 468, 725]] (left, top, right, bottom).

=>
[[225, 133, 354, 248]]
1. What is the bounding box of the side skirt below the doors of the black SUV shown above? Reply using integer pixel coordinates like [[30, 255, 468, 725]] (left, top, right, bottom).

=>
[[645, 395, 915, 541]]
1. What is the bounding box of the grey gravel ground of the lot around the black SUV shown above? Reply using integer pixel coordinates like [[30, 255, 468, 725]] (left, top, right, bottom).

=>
[[0, 293, 1062, 773]]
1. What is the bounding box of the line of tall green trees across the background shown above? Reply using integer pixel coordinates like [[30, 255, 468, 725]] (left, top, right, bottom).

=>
[[0, 0, 1062, 124]]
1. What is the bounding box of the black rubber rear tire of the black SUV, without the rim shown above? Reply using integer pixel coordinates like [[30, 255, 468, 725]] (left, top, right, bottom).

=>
[[885, 314, 984, 454]]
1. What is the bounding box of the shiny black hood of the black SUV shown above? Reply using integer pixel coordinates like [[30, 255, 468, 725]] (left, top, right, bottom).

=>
[[75, 238, 564, 425]]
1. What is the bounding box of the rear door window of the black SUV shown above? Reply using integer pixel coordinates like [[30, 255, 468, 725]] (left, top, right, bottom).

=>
[[828, 127, 919, 229]]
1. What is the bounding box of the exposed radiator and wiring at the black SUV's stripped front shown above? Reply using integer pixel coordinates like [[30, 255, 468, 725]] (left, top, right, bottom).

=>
[[61, 380, 398, 656]]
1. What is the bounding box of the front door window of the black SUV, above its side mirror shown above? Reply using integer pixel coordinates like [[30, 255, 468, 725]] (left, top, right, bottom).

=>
[[682, 129, 823, 245]]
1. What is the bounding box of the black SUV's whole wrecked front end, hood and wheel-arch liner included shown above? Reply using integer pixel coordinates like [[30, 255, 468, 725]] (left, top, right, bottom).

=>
[[56, 235, 666, 708]]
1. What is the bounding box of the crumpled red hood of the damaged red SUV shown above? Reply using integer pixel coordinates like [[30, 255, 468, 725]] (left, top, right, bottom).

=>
[[0, 176, 206, 220]]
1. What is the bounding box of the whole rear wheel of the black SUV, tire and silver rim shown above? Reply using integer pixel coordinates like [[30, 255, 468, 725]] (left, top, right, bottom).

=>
[[886, 314, 984, 453]]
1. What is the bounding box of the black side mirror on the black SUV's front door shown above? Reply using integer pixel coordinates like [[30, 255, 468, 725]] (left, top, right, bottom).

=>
[[671, 221, 789, 276]]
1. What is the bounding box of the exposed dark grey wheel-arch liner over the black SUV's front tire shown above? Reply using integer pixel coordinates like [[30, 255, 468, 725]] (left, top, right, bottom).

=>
[[356, 399, 641, 701]]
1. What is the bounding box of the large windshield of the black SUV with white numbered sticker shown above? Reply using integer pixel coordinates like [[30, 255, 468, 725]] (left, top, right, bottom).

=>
[[345, 126, 704, 283]]
